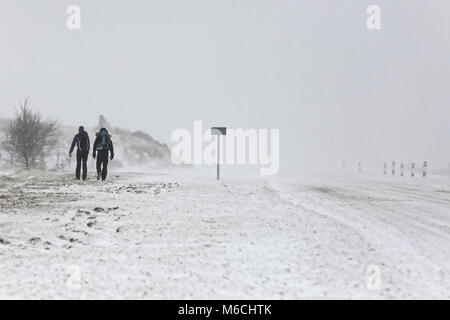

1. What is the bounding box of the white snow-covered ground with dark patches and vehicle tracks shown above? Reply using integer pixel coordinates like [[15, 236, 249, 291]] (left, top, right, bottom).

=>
[[0, 169, 450, 299]]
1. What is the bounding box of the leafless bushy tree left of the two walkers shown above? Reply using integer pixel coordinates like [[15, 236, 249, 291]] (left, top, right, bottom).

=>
[[3, 98, 58, 168]]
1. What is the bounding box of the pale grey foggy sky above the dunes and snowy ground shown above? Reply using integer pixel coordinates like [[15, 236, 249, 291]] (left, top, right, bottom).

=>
[[0, 0, 450, 172]]
